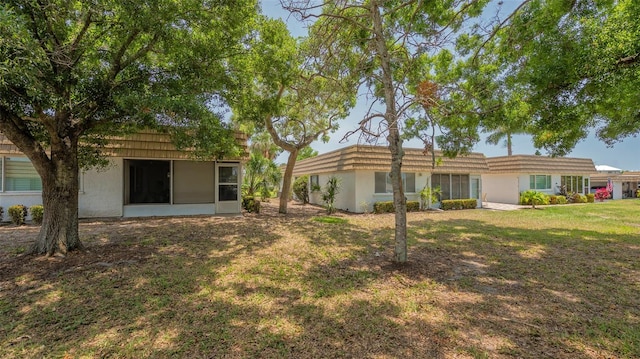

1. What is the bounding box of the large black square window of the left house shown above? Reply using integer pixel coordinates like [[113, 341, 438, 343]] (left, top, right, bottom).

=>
[[125, 160, 171, 203]]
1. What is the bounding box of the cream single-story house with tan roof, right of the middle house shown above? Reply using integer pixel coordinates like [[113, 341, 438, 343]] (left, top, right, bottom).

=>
[[482, 155, 596, 204]]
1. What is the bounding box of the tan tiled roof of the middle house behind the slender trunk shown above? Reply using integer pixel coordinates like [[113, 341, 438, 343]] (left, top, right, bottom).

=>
[[293, 145, 489, 176]]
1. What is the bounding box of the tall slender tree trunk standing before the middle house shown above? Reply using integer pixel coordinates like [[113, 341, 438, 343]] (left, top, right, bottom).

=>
[[371, 1, 407, 263]]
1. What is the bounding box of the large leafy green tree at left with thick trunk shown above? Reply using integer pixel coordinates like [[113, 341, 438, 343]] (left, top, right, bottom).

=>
[[0, 0, 257, 255]]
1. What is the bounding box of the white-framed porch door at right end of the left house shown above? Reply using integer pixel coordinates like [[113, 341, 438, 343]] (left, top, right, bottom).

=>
[[216, 163, 240, 213]]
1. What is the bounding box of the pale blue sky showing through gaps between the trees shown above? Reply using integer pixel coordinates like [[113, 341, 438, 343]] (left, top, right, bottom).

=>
[[261, 0, 640, 171]]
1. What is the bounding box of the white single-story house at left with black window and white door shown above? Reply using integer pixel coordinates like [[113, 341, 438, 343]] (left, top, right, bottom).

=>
[[0, 131, 246, 219]]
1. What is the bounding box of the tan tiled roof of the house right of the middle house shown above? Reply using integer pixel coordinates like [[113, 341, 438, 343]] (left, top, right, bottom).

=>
[[487, 155, 596, 175]]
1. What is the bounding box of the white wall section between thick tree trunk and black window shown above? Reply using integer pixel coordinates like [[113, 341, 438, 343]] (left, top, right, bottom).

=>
[[78, 158, 124, 218]]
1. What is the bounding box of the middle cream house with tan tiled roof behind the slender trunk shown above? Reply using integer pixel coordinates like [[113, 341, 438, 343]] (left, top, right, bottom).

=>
[[293, 145, 489, 213]]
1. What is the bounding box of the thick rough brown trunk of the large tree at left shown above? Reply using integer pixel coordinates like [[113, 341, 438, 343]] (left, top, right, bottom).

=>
[[31, 137, 82, 255]]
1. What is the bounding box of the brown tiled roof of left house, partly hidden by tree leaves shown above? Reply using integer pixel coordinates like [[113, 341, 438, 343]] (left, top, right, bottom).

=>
[[0, 130, 247, 159]]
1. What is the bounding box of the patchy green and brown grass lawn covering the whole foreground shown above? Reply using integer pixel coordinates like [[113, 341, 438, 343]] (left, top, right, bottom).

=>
[[0, 200, 640, 358]]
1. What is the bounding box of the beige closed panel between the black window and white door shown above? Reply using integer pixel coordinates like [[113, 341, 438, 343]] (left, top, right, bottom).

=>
[[173, 161, 215, 204]]
